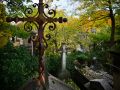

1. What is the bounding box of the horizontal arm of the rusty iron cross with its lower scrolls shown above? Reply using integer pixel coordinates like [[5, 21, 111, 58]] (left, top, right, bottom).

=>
[[6, 16, 67, 32]]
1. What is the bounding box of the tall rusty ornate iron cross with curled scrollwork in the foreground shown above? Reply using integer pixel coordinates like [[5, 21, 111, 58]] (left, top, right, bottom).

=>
[[6, 0, 67, 88]]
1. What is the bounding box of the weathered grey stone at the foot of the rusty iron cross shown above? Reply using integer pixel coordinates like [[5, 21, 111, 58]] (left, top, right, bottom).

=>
[[19, 75, 73, 90]]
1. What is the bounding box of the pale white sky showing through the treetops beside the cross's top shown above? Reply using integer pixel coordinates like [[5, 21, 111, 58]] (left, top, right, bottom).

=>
[[32, 0, 79, 16]]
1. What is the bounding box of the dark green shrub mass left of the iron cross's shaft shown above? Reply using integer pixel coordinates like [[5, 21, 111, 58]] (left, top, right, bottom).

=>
[[0, 43, 38, 90]]
